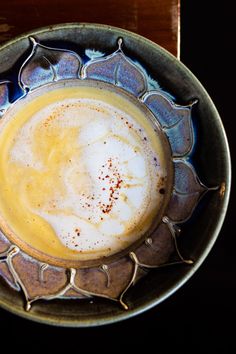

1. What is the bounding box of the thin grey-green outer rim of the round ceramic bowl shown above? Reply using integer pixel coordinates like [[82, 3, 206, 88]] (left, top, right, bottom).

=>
[[0, 22, 231, 327]]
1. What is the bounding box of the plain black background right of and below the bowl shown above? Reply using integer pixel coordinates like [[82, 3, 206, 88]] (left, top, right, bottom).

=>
[[0, 0, 236, 353]]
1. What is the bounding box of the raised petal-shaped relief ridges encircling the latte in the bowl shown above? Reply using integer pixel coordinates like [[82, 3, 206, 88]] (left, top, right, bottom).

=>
[[0, 37, 218, 311]]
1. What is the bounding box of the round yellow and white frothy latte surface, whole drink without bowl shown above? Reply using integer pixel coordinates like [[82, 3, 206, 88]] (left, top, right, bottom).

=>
[[0, 80, 172, 266]]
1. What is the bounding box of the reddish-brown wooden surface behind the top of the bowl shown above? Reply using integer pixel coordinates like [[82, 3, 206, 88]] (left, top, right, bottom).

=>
[[0, 0, 180, 56]]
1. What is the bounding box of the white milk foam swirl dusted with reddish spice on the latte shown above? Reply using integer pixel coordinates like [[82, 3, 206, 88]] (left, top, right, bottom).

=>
[[0, 85, 170, 258]]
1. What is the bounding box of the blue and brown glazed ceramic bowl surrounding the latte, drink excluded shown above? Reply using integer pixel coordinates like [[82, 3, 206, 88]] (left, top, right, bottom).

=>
[[0, 24, 230, 326]]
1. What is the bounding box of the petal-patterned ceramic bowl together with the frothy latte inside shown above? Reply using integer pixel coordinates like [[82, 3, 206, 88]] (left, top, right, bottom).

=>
[[0, 24, 231, 326]]
